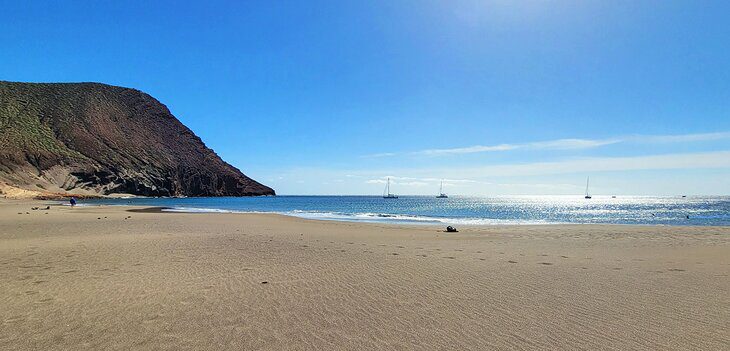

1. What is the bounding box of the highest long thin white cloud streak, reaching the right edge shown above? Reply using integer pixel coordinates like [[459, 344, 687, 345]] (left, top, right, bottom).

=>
[[363, 132, 730, 158]]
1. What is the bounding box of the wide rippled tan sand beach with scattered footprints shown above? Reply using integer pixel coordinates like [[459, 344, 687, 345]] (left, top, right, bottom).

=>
[[0, 200, 730, 350]]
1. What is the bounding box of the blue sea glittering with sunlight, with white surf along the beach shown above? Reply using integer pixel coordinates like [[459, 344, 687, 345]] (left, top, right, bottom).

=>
[[82, 195, 730, 226]]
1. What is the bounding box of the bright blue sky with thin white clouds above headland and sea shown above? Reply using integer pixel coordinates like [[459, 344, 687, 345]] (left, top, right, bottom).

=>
[[0, 0, 730, 195]]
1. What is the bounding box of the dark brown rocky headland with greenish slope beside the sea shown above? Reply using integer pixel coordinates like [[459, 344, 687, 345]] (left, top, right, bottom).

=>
[[0, 81, 274, 196]]
